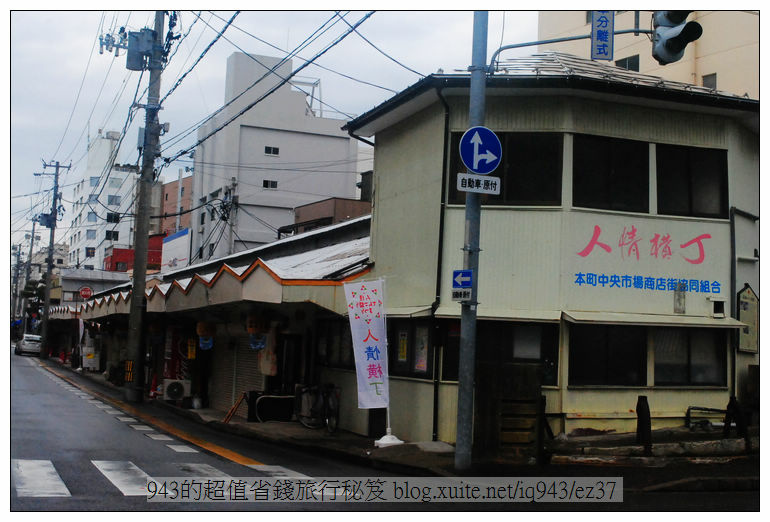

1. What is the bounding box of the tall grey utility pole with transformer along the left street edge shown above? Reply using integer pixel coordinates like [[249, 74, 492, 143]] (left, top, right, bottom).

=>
[[125, 11, 165, 402]]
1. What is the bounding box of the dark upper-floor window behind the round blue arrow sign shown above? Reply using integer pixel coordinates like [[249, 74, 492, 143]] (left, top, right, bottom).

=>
[[449, 132, 564, 206]]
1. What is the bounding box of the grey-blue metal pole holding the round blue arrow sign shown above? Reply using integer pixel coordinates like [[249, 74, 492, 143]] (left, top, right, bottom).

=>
[[455, 11, 489, 470]]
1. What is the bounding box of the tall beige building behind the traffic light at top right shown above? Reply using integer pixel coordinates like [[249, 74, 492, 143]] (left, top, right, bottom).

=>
[[536, 11, 759, 99]]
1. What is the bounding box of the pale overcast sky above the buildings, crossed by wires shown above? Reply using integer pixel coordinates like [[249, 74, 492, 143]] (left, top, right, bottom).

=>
[[10, 11, 537, 248]]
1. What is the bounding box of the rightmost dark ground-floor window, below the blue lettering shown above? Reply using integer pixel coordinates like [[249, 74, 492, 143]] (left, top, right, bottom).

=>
[[652, 328, 727, 386]]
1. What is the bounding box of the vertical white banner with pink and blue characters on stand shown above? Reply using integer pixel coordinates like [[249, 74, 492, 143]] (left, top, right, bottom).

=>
[[344, 279, 389, 409]]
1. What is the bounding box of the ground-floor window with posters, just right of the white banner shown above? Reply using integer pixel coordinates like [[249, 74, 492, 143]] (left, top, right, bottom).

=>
[[388, 319, 433, 379]]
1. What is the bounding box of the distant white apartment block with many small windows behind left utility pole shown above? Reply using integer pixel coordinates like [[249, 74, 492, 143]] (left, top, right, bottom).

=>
[[65, 130, 160, 270]]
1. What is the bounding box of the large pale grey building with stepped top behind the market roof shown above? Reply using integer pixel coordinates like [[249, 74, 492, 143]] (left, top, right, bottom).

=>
[[190, 53, 358, 264]]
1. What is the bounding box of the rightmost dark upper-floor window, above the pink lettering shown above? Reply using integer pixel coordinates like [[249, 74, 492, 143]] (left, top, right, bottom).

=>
[[656, 145, 728, 218]]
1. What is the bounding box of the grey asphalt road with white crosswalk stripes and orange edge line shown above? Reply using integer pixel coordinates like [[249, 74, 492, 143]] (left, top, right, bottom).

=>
[[10, 348, 759, 511]]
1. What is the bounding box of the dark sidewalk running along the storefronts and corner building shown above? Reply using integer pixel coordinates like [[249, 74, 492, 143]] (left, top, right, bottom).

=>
[[41, 359, 759, 491]]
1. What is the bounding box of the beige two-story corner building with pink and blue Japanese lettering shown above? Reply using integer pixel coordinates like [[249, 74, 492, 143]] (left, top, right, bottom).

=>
[[340, 53, 759, 460]]
